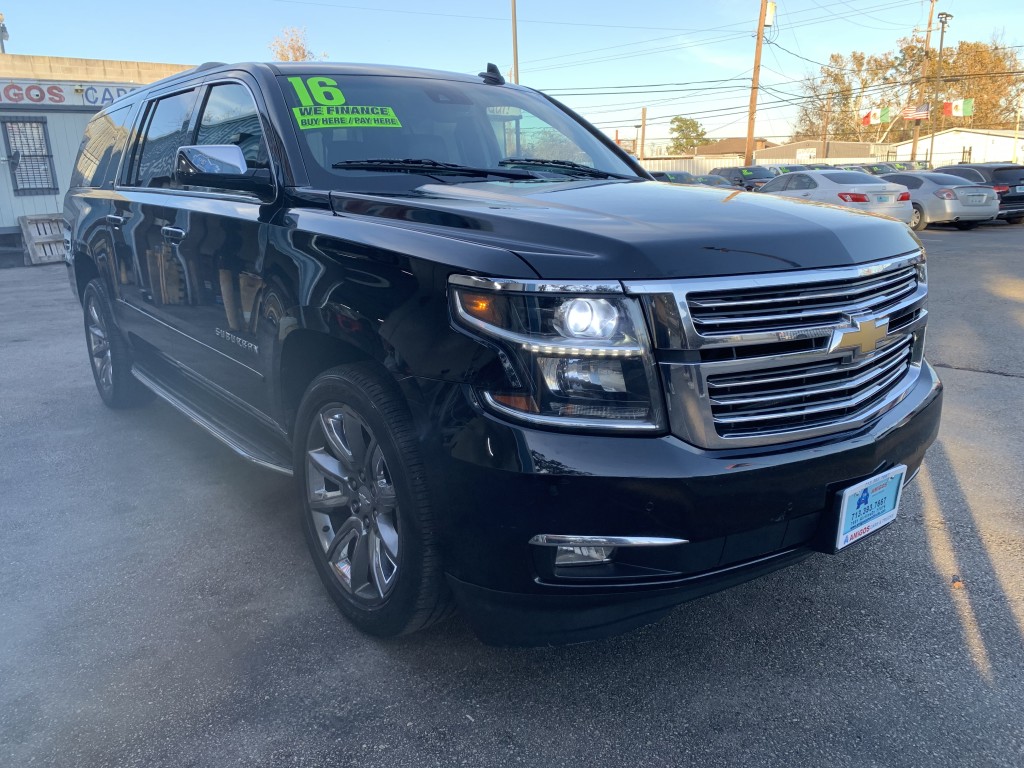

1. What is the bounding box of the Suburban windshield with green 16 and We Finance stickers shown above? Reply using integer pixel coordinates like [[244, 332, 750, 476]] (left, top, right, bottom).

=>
[[279, 74, 638, 189]]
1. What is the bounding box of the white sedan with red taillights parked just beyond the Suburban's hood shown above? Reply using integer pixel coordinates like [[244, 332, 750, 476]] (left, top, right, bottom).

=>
[[758, 171, 913, 224]]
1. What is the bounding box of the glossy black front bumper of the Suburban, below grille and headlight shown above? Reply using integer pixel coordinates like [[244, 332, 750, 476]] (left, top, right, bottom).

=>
[[411, 364, 942, 644]]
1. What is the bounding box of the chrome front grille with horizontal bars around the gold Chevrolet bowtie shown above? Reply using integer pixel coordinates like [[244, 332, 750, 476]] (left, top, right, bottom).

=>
[[626, 253, 928, 449]]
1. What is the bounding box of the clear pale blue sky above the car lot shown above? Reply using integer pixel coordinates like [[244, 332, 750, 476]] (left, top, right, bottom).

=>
[[0, 0, 1024, 142]]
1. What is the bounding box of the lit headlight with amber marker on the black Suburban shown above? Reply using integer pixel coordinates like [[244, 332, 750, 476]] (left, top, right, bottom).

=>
[[450, 275, 664, 430]]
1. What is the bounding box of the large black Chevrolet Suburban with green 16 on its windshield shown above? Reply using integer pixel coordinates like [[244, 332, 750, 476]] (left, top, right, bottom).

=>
[[65, 62, 941, 643]]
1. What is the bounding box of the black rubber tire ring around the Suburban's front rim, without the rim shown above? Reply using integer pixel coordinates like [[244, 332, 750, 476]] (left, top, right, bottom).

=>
[[293, 364, 438, 637]]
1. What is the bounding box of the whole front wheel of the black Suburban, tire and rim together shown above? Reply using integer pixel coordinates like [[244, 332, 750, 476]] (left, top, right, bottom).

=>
[[294, 362, 454, 637]]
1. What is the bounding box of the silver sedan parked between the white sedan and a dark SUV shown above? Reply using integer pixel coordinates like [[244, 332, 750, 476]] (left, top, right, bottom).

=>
[[882, 171, 999, 230]]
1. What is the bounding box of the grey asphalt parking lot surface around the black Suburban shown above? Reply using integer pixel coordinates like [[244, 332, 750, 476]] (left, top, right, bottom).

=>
[[0, 223, 1024, 768]]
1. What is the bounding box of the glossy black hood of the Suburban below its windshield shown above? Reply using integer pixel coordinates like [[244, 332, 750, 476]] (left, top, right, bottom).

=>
[[331, 180, 921, 280]]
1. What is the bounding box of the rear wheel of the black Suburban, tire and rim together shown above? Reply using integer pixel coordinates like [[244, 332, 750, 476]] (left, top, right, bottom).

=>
[[82, 278, 152, 409]]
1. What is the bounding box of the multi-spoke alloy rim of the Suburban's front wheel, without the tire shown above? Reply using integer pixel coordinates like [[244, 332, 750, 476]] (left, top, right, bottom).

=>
[[306, 404, 399, 605]]
